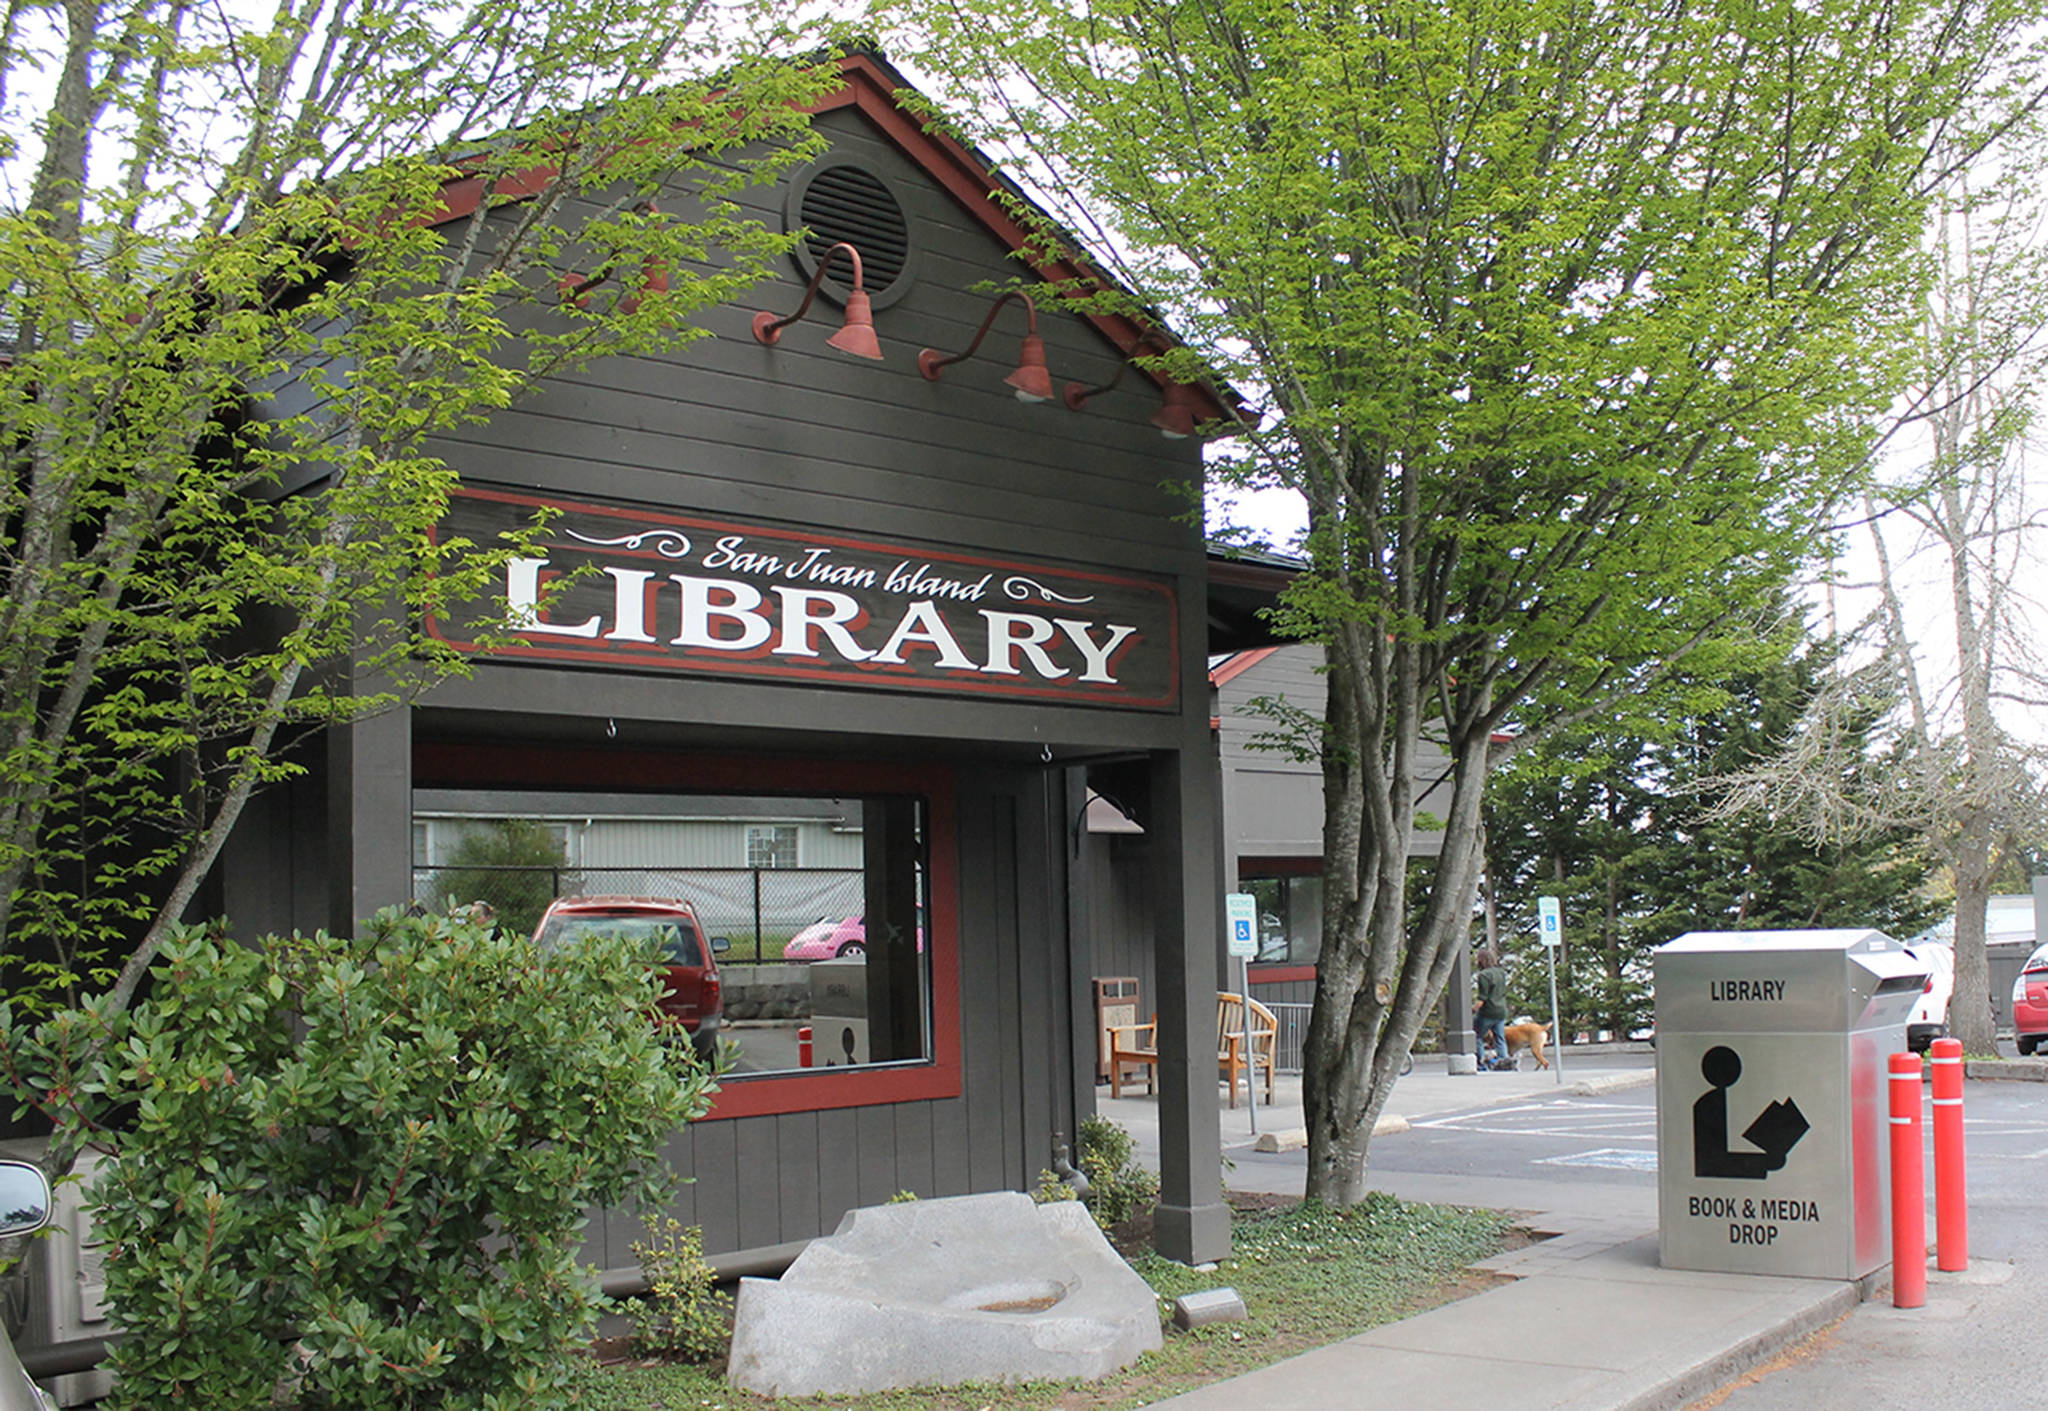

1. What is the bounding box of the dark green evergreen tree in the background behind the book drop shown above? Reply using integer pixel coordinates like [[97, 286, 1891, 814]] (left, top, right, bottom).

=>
[[1487, 618, 1942, 1034]]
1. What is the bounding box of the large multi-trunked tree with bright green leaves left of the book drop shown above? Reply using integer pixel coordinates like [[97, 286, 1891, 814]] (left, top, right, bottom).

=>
[[893, 0, 2040, 1204]]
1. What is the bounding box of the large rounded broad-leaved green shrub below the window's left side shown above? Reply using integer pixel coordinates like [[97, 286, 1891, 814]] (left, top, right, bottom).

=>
[[0, 911, 711, 1411]]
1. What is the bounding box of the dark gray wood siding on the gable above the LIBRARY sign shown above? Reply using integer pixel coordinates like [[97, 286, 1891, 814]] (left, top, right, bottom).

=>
[[438, 103, 1202, 577]]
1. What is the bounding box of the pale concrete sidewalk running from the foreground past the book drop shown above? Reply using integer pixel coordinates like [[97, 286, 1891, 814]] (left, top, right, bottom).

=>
[[1098, 1051, 1884, 1411]]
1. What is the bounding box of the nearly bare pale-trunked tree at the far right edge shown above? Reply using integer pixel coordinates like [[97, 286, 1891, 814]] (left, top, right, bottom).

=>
[[1722, 156, 2048, 1053]]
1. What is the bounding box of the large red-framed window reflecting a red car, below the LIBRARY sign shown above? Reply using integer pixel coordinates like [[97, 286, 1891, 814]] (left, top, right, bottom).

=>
[[414, 741, 958, 1116]]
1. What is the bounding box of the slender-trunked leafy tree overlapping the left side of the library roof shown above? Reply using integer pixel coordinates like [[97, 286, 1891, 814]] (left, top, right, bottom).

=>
[[0, 0, 831, 1023]]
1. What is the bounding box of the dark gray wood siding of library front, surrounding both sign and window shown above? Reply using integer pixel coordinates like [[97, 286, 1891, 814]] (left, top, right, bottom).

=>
[[266, 93, 1214, 1272]]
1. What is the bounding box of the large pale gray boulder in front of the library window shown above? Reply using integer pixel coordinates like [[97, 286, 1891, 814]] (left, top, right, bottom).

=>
[[729, 1192, 1159, 1397]]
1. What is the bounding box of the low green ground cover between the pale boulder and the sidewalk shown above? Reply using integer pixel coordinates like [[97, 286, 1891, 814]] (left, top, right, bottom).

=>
[[575, 1194, 1509, 1411]]
